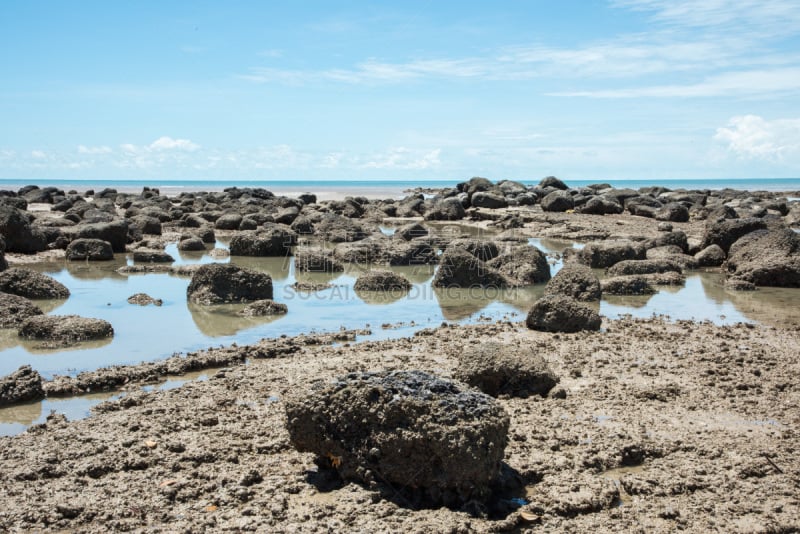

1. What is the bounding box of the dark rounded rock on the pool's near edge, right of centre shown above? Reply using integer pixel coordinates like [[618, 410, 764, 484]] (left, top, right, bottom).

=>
[[525, 295, 601, 332]]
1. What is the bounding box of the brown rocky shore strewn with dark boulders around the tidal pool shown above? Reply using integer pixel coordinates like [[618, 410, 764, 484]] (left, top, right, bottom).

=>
[[0, 177, 800, 532]]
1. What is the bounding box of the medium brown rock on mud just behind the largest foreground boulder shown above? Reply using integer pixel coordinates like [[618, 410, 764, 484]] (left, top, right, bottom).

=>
[[453, 341, 559, 397]]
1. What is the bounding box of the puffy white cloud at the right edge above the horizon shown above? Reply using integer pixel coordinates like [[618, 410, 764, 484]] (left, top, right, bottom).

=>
[[714, 115, 800, 161]]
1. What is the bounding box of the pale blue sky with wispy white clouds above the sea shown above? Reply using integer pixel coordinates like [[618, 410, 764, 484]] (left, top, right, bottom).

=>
[[0, 0, 800, 180]]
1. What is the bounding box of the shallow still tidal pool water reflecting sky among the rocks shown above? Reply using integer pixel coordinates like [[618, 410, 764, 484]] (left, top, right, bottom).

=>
[[0, 233, 800, 434]]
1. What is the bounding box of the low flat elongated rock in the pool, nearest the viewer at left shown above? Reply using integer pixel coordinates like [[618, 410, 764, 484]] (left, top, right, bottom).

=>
[[18, 315, 114, 344]]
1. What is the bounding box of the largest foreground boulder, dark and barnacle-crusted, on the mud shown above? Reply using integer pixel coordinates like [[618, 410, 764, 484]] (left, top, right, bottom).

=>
[[286, 371, 509, 507]]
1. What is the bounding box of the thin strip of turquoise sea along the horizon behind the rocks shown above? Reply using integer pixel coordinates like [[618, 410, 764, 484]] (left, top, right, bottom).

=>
[[0, 178, 800, 194]]
